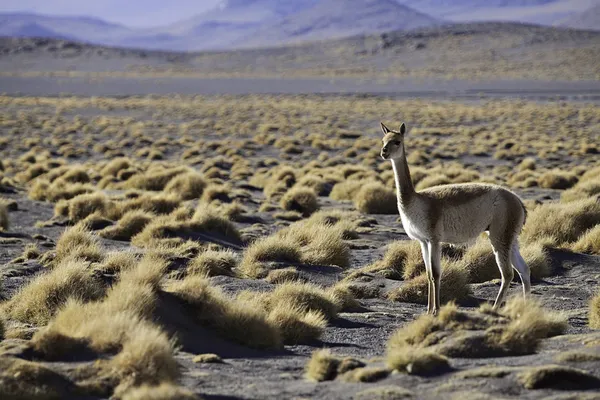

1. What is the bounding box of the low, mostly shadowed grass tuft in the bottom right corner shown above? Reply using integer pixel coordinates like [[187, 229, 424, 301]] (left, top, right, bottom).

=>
[[518, 365, 600, 390]]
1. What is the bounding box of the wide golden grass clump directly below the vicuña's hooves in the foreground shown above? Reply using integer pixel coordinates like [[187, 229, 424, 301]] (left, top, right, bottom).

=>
[[388, 297, 567, 360]]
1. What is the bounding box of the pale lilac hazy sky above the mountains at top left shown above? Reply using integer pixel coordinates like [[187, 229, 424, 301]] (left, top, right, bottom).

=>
[[0, 0, 219, 26]]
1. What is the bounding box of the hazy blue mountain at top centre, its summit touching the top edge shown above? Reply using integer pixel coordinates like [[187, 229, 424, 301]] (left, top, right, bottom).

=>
[[236, 0, 441, 47]]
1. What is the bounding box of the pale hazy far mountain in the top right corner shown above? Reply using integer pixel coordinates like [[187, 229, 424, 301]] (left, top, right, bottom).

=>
[[397, 0, 599, 25]]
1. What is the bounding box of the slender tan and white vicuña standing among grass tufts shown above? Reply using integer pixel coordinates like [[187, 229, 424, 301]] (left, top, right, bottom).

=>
[[381, 120, 530, 314]]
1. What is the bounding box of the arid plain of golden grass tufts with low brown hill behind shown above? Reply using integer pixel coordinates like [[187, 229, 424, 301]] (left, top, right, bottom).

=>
[[0, 15, 600, 400]]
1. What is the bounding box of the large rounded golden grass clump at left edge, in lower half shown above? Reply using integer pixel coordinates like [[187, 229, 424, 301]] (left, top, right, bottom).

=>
[[2, 260, 105, 325]]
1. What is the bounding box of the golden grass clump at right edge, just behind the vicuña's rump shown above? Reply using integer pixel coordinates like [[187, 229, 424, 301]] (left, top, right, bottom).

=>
[[521, 198, 600, 246]]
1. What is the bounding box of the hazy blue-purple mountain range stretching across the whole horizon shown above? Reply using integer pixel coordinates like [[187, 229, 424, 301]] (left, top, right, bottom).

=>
[[0, 0, 600, 51]]
